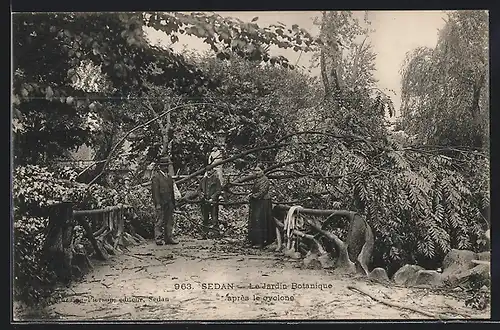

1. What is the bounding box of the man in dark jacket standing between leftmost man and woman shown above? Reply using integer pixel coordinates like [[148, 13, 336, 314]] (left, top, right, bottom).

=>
[[200, 170, 222, 236]]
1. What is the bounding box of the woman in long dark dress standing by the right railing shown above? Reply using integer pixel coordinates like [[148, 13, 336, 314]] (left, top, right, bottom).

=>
[[248, 166, 276, 248]]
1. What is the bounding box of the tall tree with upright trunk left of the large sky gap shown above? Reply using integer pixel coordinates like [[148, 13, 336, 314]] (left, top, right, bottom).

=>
[[306, 11, 394, 138]]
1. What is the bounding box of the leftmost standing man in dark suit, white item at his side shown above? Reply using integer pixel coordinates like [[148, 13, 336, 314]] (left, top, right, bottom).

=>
[[151, 157, 177, 245]]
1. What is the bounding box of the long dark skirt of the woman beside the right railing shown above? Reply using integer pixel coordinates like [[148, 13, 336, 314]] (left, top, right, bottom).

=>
[[248, 198, 276, 247]]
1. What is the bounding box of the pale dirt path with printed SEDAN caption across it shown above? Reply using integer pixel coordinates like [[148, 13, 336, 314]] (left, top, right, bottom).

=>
[[14, 238, 490, 321]]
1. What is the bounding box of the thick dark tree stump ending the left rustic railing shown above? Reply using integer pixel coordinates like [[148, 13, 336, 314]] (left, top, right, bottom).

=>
[[43, 202, 74, 283]]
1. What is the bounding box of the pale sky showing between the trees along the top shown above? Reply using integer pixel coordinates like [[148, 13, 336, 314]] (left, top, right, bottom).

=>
[[147, 11, 445, 118]]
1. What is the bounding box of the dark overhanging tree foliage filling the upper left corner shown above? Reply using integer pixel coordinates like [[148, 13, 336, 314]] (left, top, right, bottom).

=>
[[13, 13, 315, 168]]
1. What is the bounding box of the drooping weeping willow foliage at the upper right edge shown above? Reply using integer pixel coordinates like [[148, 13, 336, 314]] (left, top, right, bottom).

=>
[[401, 11, 489, 148]]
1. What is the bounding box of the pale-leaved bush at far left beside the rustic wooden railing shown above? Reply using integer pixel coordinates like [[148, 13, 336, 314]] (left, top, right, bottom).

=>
[[12, 165, 123, 303]]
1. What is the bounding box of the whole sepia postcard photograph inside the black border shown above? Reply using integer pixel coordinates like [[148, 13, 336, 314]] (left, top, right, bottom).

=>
[[10, 10, 491, 323]]
